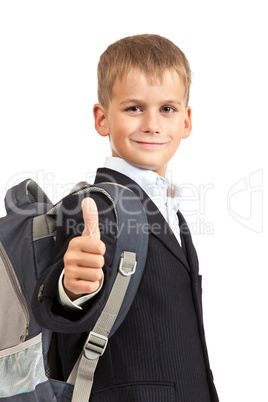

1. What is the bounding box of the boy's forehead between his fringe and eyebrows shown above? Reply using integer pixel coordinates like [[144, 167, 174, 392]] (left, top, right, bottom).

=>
[[112, 69, 185, 99]]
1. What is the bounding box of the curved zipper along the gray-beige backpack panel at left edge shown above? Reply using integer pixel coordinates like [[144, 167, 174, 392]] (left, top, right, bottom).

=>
[[0, 241, 30, 342]]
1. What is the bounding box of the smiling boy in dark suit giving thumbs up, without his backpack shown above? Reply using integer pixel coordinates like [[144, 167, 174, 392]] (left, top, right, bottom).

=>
[[33, 35, 218, 402]]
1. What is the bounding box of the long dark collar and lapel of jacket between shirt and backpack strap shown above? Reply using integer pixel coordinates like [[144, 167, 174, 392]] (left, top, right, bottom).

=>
[[95, 168, 190, 271]]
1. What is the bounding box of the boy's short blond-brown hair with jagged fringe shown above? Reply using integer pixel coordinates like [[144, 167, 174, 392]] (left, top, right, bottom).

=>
[[98, 34, 191, 108]]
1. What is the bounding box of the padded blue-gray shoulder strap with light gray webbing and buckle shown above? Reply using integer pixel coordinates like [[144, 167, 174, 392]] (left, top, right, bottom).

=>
[[67, 183, 148, 402]]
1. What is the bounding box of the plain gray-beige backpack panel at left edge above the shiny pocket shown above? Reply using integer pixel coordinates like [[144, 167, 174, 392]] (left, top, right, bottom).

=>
[[0, 241, 30, 350]]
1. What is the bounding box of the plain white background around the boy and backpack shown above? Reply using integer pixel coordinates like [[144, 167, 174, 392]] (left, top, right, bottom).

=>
[[0, 0, 268, 402]]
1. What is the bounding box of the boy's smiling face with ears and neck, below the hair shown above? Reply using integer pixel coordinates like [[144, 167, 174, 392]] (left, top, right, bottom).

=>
[[94, 70, 192, 177]]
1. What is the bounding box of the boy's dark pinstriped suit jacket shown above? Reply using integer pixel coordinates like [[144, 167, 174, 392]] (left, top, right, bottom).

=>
[[34, 168, 218, 402]]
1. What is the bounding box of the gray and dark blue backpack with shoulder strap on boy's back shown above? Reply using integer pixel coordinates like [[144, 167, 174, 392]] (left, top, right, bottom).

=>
[[0, 179, 148, 402]]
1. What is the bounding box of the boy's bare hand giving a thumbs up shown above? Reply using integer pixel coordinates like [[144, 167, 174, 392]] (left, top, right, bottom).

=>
[[63, 197, 105, 301]]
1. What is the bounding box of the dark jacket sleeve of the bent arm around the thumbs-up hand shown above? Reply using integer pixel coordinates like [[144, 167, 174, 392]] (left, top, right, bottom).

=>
[[32, 193, 116, 333]]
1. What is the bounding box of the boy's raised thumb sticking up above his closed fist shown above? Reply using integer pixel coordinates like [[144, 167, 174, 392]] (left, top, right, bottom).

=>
[[81, 197, 100, 239]]
